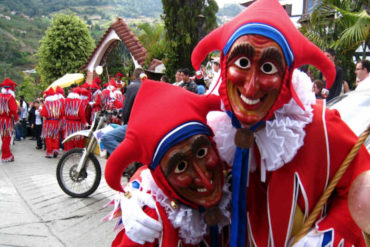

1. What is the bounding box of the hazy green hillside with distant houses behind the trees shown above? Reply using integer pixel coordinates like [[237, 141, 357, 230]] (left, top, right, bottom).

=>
[[0, 0, 241, 82]]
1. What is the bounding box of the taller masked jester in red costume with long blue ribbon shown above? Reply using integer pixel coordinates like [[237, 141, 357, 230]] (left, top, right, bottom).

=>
[[192, 0, 370, 247]]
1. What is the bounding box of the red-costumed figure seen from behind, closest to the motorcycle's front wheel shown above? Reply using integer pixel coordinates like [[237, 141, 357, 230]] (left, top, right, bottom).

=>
[[64, 87, 87, 151]]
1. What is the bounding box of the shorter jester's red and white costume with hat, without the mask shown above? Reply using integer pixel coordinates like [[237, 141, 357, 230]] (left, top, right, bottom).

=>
[[105, 80, 231, 247]]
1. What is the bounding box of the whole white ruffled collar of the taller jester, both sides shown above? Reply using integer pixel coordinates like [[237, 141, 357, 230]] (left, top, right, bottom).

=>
[[207, 70, 316, 181]]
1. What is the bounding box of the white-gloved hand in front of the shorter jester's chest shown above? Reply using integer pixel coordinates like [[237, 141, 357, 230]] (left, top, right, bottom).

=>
[[121, 189, 163, 244]]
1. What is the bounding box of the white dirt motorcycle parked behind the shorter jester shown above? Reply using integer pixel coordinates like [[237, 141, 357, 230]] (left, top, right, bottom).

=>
[[56, 110, 139, 198]]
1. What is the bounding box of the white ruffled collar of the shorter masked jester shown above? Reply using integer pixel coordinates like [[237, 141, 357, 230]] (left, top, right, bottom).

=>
[[140, 169, 231, 244]]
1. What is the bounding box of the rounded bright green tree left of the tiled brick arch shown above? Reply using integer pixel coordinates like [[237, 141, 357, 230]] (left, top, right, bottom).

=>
[[37, 14, 94, 84]]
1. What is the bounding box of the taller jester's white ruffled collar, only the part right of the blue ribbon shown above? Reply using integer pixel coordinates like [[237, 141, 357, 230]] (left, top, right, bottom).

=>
[[251, 70, 316, 178]]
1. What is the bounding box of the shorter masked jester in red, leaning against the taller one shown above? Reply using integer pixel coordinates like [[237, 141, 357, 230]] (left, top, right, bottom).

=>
[[105, 80, 230, 247]]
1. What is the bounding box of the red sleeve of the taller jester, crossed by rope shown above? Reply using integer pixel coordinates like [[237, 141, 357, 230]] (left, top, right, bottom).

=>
[[318, 107, 370, 246]]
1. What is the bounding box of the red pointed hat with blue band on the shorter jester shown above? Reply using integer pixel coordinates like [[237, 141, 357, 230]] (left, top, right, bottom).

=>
[[105, 80, 221, 206]]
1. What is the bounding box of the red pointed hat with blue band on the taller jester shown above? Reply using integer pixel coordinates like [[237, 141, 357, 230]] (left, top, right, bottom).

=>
[[191, 0, 335, 119]]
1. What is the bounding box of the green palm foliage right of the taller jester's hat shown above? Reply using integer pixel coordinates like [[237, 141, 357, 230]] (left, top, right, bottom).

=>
[[301, 0, 370, 88]]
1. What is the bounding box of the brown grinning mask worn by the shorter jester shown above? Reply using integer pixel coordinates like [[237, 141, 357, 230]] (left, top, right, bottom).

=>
[[159, 134, 223, 208]]
